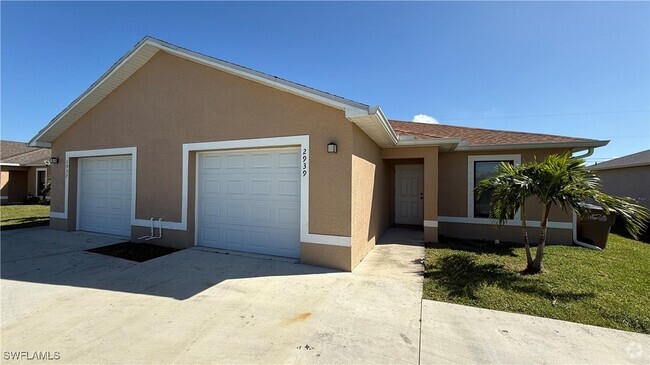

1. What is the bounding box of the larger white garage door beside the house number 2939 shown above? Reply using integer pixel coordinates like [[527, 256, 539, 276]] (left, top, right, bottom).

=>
[[197, 148, 300, 257]]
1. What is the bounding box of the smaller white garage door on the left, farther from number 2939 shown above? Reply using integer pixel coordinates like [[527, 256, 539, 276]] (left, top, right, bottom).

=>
[[78, 156, 132, 236]]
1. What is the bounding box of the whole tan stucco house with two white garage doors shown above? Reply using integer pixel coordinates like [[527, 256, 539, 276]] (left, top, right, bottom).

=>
[[30, 37, 607, 270]]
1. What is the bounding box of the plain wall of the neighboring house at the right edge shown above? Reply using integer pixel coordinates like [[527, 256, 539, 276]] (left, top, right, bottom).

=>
[[594, 166, 650, 209]]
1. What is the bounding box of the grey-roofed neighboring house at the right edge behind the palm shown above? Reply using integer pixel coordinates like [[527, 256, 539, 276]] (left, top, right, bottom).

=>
[[589, 150, 650, 209]]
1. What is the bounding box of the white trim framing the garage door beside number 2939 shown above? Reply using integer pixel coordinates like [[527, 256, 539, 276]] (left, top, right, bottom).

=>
[[185, 135, 352, 247]]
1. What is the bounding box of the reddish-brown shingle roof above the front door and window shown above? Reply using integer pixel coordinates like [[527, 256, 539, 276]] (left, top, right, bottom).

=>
[[390, 120, 608, 150]]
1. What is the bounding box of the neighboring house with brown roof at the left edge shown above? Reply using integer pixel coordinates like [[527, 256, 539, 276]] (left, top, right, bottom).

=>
[[0, 141, 51, 204]]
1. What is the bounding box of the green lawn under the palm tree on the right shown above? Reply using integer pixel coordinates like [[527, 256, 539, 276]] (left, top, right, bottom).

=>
[[424, 234, 650, 333]]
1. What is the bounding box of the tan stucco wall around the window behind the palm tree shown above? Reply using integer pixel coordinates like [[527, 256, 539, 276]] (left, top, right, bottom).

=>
[[438, 149, 572, 244]]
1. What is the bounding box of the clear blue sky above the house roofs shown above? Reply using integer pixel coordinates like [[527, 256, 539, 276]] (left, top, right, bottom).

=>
[[0, 1, 650, 161]]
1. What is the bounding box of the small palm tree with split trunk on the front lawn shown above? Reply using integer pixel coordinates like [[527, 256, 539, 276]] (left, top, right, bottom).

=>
[[477, 153, 650, 273]]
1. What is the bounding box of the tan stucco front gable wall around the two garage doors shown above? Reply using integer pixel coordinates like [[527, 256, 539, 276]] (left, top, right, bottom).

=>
[[51, 52, 353, 268]]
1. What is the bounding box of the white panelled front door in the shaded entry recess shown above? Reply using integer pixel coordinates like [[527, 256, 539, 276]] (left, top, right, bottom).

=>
[[395, 165, 424, 226]]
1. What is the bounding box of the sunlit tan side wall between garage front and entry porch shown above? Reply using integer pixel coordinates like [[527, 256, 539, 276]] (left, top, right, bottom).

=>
[[351, 126, 389, 268]]
